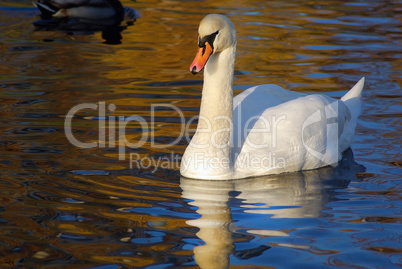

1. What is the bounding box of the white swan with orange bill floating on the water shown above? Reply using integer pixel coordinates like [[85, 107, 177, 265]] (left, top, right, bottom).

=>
[[180, 14, 364, 180]]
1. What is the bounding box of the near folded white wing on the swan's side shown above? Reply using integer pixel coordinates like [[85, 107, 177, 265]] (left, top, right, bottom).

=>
[[232, 93, 350, 175]]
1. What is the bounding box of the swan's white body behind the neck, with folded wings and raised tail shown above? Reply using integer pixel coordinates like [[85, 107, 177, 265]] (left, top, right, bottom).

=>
[[232, 80, 364, 177]]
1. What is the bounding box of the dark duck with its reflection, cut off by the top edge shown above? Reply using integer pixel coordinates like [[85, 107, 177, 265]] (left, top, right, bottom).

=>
[[33, 0, 141, 44]]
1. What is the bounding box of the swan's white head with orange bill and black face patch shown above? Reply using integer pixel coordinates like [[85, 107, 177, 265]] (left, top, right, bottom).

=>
[[190, 14, 236, 74]]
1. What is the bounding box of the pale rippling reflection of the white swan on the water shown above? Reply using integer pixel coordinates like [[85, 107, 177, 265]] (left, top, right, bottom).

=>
[[180, 149, 364, 268]]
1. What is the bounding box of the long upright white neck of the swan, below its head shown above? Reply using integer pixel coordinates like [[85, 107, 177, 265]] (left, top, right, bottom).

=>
[[190, 45, 236, 178]]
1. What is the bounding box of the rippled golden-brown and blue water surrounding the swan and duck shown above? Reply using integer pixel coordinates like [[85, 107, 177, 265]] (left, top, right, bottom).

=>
[[0, 0, 402, 268]]
